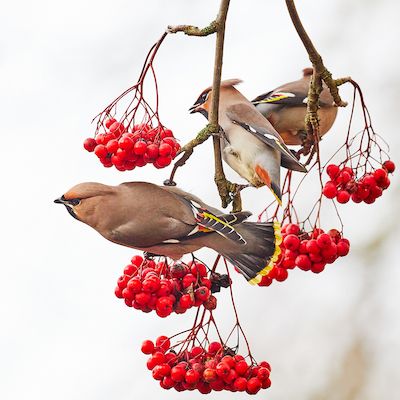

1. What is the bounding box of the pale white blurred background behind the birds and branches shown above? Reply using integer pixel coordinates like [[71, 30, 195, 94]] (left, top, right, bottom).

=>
[[0, 0, 400, 400]]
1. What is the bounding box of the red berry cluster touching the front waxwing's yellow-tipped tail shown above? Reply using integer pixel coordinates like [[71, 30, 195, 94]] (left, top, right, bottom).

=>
[[258, 224, 350, 286]]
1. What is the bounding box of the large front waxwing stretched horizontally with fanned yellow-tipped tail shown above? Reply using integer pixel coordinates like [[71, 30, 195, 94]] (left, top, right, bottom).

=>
[[54, 182, 282, 283]]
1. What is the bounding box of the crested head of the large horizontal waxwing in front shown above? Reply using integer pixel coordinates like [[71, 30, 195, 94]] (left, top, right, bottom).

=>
[[54, 182, 111, 225]]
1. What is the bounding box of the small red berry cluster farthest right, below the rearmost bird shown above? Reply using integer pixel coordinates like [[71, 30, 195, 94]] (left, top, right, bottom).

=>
[[322, 160, 395, 204]]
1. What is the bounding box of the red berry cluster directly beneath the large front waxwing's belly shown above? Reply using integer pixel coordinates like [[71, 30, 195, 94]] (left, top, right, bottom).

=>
[[115, 256, 230, 318]]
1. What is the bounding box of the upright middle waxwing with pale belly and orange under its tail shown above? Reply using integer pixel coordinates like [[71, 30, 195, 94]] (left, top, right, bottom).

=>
[[190, 79, 307, 204]]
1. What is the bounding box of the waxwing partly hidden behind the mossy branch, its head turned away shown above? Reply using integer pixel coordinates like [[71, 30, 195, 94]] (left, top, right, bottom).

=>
[[252, 68, 337, 145]]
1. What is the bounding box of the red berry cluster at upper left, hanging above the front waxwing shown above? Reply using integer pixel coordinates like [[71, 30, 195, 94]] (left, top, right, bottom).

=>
[[83, 119, 180, 171]]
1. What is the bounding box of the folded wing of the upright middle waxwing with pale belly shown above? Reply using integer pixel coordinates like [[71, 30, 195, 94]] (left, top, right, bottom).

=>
[[226, 103, 307, 172]]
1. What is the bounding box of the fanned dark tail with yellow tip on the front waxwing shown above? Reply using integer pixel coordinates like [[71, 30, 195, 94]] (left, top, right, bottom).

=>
[[220, 222, 282, 285]]
